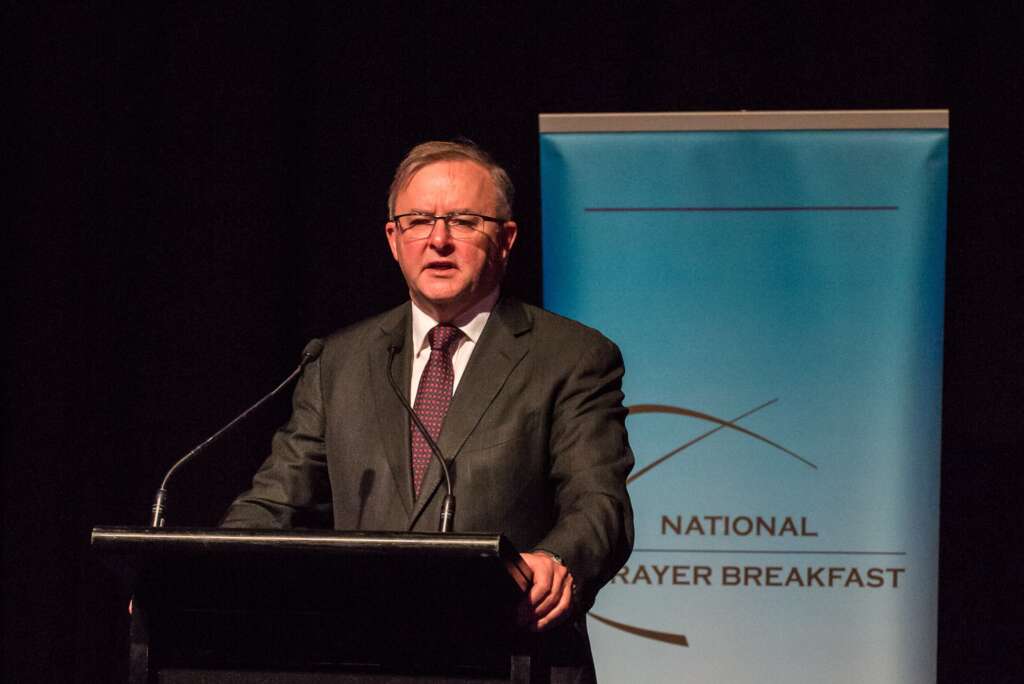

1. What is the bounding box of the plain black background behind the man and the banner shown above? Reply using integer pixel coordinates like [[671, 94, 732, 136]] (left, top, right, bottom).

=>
[[2, 2, 1024, 682]]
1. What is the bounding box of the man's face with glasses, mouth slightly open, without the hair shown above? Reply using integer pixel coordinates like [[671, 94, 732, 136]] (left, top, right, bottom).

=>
[[385, 160, 516, 322]]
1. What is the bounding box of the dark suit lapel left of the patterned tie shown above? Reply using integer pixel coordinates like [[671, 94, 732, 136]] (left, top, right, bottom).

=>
[[370, 304, 413, 515]]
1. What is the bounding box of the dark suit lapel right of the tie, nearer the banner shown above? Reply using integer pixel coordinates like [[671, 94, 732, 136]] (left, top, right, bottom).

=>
[[407, 299, 532, 529]]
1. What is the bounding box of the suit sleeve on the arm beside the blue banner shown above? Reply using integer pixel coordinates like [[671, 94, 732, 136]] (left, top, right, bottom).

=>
[[536, 338, 633, 610]]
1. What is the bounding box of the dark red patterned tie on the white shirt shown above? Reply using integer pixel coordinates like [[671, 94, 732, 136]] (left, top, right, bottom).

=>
[[409, 324, 462, 497]]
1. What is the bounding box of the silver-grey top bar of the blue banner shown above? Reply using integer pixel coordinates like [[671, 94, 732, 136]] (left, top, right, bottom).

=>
[[539, 110, 949, 133]]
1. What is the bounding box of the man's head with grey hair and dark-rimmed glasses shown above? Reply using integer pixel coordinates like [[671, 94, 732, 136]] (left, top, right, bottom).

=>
[[385, 142, 517, 322]]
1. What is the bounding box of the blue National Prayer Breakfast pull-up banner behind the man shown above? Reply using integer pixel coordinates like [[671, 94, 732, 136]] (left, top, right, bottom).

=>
[[541, 112, 948, 684]]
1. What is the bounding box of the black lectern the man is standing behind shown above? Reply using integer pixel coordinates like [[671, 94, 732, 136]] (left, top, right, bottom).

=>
[[92, 527, 537, 684]]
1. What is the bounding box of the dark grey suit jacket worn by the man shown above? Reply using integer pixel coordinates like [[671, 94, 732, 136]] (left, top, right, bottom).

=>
[[222, 299, 633, 679]]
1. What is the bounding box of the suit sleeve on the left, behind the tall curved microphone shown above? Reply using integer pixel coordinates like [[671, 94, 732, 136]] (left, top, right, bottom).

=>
[[220, 358, 331, 528]]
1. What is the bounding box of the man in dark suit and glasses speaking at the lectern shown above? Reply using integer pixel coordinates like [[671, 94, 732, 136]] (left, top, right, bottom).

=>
[[223, 142, 633, 678]]
